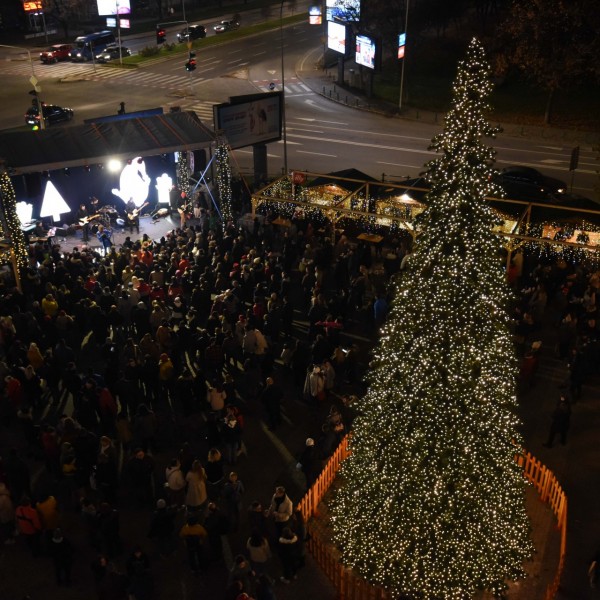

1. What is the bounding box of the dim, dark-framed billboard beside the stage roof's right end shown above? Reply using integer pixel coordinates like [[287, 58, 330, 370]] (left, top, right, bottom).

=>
[[214, 92, 282, 149]]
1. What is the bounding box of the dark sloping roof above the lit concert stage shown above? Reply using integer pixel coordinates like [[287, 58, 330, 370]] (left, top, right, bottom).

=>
[[0, 111, 215, 175]]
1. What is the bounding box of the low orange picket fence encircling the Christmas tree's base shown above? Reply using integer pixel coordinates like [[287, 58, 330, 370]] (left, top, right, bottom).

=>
[[297, 435, 567, 600]]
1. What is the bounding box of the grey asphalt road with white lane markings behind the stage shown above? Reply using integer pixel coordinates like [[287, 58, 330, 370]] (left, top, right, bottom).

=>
[[0, 15, 597, 197]]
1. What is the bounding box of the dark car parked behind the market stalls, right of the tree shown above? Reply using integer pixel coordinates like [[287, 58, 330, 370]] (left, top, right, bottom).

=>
[[496, 166, 567, 202]]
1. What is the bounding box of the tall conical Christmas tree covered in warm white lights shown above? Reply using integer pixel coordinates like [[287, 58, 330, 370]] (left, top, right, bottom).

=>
[[332, 40, 533, 600]]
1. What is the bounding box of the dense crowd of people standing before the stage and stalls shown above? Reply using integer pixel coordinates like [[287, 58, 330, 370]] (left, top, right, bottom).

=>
[[0, 189, 600, 600]]
